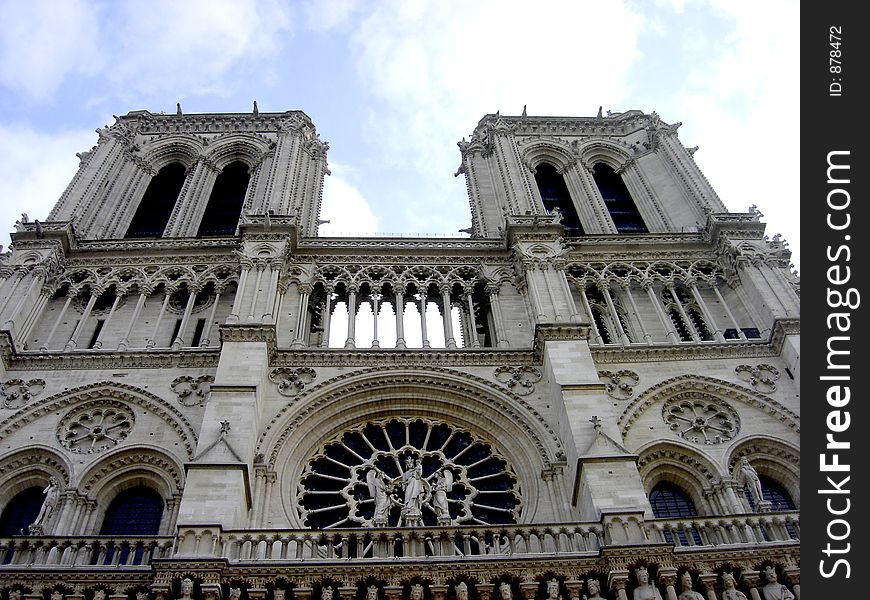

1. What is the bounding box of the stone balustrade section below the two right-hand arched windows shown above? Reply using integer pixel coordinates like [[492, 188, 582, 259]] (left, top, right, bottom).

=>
[[644, 512, 800, 549]]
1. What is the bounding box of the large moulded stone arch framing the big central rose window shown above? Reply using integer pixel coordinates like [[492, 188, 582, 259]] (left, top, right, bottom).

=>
[[257, 369, 563, 522]]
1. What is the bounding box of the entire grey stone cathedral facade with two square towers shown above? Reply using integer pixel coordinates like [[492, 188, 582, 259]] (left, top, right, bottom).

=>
[[0, 111, 800, 600]]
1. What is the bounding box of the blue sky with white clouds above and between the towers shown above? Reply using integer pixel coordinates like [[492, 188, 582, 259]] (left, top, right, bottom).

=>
[[0, 0, 800, 267]]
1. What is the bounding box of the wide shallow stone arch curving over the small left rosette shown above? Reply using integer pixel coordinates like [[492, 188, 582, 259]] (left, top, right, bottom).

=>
[[0, 381, 197, 458]]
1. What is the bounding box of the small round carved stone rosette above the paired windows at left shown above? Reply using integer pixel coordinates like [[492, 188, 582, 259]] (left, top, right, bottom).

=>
[[57, 402, 134, 454]]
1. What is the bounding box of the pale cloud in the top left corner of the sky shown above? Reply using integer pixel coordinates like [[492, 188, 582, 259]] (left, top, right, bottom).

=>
[[0, 0, 104, 100]]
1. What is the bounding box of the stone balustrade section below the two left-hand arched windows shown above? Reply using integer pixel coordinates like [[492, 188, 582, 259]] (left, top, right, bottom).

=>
[[0, 536, 173, 569]]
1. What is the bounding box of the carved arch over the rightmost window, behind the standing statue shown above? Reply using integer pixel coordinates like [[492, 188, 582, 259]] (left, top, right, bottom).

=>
[[723, 436, 801, 508]]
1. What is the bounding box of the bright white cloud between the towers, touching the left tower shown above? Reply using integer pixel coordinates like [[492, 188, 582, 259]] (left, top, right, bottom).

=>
[[318, 168, 378, 237]]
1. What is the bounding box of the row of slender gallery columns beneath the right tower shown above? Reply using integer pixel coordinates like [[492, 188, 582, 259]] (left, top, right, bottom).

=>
[[575, 279, 747, 345]]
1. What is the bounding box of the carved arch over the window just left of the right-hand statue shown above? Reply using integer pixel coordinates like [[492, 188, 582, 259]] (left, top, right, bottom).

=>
[[637, 441, 720, 513]]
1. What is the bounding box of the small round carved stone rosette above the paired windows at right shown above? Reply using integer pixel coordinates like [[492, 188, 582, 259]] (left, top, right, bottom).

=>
[[662, 395, 740, 446]]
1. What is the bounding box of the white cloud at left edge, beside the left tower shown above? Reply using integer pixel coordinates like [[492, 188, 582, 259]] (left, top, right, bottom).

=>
[[0, 125, 97, 247]]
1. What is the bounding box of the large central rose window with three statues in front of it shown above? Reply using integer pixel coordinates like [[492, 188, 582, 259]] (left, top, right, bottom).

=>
[[298, 419, 521, 529]]
